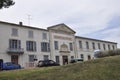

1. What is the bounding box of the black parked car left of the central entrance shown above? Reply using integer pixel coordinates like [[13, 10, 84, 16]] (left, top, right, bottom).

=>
[[37, 60, 60, 67]]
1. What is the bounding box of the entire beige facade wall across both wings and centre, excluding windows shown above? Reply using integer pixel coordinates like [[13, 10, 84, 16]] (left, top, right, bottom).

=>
[[0, 23, 117, 67]]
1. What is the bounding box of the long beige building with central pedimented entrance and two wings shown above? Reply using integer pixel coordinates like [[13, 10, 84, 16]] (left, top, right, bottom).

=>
[[0, 21, 117, 67]]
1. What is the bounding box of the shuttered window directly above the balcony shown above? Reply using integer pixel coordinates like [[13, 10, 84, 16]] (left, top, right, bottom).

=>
[[9, 39, 21, 49]]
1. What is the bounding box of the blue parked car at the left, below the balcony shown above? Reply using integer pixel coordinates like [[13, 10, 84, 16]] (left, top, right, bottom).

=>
[[2, 62, 21, 70]]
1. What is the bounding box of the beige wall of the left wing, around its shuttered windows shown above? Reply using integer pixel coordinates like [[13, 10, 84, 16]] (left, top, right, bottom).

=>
[[0, 24, 50, 66]]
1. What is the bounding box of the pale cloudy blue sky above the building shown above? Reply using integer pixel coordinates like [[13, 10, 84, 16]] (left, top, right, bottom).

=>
[[0, 0, 120, 48]]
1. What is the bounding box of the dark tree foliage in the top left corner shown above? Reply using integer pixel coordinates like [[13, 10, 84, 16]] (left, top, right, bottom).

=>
[[0, 0, 15, 9]]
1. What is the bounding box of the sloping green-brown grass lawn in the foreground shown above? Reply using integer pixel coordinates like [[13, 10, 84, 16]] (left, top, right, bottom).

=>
[[0, 56, 120, 80]]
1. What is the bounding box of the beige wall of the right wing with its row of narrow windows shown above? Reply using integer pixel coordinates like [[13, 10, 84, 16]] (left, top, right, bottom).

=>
[[76, 38, 117, 60]]
